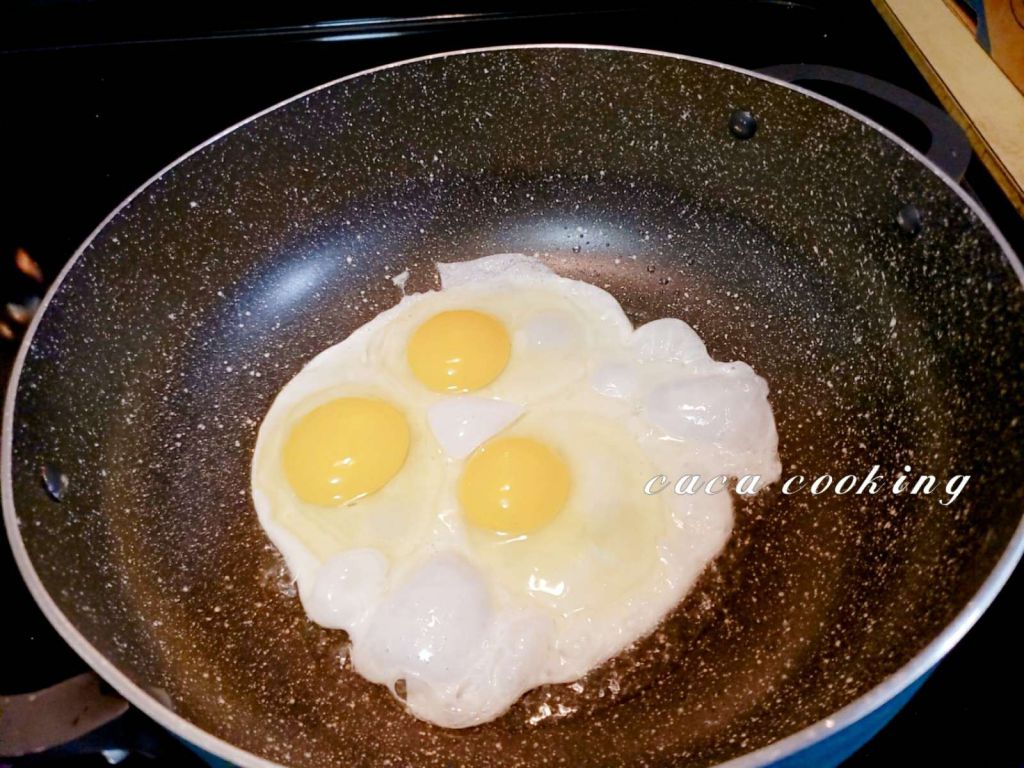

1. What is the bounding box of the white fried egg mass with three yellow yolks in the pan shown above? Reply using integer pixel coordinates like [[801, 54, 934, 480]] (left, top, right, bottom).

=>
[[252, 254, 780, 728]]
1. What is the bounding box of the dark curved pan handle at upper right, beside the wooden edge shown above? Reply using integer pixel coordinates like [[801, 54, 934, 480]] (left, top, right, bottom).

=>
[[758, 63, 971, 183]]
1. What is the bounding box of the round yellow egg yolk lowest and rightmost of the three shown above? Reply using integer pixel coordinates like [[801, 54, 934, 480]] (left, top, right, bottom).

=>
[[459, 437, 570, 536]]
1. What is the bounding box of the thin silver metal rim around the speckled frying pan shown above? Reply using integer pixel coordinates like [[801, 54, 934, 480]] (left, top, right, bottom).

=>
[[0, 43, 1024, 768]]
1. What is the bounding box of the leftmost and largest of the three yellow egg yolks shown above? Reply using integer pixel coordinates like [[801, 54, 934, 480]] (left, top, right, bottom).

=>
[[284, 397, 409, 507]]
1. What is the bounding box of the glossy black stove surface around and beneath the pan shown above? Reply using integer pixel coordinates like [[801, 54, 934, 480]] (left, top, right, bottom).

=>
[[0, 0, 1024, 768]]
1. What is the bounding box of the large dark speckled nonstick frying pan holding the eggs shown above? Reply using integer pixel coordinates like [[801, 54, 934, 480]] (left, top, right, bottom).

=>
[[3, 46, 1024, 766]]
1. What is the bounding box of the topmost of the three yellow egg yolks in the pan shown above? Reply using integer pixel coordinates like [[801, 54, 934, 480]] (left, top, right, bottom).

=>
[[406, 309, 512, 392]]
